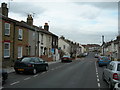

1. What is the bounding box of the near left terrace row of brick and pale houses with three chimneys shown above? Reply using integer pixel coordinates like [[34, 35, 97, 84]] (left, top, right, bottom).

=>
[[0, 3, 59, 67]]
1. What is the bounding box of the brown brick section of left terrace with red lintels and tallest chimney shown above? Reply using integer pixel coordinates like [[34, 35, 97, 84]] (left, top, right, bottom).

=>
[[0, 3, 28, 67]]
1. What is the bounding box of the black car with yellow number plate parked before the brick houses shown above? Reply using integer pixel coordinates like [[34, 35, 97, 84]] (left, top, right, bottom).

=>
[[14, 57, 49, 74]]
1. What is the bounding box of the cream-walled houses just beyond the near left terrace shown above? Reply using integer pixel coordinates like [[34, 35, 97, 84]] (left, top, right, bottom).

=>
[[58, 36, 84, 57]]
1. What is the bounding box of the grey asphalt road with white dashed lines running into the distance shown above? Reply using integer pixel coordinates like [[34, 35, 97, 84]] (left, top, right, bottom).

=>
[[3, 53, 108, 88]]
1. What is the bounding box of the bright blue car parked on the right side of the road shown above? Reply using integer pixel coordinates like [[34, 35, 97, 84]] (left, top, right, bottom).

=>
[[98, 56, 111, 66]]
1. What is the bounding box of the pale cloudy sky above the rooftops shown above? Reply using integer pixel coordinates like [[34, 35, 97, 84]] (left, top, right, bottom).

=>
[[1, 0, 118, 44]]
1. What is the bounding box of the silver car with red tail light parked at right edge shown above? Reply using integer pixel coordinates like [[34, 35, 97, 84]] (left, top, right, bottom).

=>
[[102, 61, 120, 90]]
